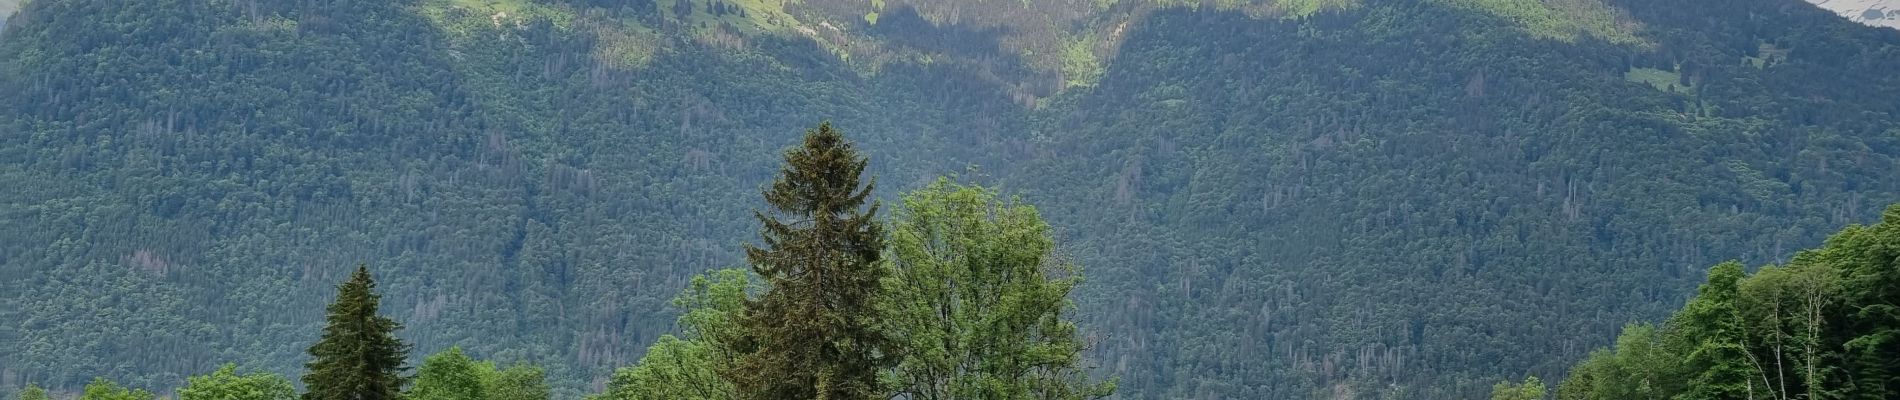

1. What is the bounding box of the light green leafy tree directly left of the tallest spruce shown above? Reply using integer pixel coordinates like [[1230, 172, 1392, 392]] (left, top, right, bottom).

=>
[[597, 269, 752, 400]]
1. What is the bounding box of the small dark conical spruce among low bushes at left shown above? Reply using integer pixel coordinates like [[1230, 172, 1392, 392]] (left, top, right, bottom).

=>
[[304, 265, 409, 400]]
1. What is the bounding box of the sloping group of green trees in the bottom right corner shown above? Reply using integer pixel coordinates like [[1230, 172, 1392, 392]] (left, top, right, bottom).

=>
[[1558, 205, 1900, 400]]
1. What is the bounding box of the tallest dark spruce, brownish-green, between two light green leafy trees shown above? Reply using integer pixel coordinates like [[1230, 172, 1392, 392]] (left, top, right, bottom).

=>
[[722, 121, 895, 400]]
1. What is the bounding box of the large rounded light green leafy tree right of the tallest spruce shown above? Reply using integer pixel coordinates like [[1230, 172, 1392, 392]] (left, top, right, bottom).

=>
[[884, 178, 1115, 400]]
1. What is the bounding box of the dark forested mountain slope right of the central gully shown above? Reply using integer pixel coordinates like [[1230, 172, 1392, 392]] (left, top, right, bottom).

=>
[[1024, 4, 1900, 398]]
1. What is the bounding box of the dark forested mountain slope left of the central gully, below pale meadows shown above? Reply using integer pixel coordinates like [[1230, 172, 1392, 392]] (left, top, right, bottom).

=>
[[0, 0, 1013, 396]]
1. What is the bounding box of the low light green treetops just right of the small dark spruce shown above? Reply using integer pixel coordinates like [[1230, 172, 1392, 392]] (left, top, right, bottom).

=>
[[403, 347, 551, 400]]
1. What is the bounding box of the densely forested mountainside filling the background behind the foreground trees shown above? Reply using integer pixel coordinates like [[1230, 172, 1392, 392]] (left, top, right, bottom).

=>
[[0, 0, 1900, 398]]
